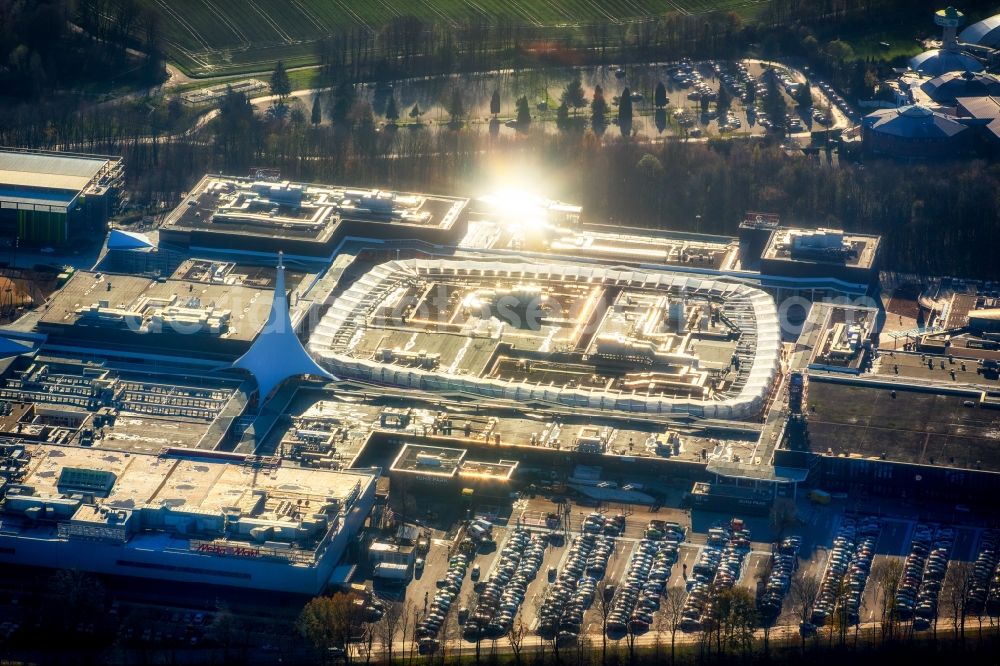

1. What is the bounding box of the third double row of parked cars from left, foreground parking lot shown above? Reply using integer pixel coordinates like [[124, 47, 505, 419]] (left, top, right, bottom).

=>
[[538, 534, 615, 643]]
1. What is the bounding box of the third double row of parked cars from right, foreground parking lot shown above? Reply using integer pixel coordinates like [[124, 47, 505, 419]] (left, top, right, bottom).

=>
[[812, 517, 881, 626]]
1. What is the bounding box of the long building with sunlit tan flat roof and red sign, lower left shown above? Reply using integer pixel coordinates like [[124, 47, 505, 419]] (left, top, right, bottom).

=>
[[0, 443, 376, 594]]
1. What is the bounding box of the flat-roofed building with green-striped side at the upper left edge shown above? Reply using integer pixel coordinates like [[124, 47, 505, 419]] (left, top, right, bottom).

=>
[[0, 150, 124, 245]]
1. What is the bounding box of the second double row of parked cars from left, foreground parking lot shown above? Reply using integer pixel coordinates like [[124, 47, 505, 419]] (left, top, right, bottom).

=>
[[463, 528, 548, 640]]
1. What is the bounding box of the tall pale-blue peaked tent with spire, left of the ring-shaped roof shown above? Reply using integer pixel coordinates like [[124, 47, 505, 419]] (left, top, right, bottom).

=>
[[232, 254, 336, 403]]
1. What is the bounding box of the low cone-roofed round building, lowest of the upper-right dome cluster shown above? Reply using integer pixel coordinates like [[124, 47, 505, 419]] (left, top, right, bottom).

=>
[[861, 105, 973, 159]]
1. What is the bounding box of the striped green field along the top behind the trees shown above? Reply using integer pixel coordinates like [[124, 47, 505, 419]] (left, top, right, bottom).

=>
[[141, 0, 768, 75]]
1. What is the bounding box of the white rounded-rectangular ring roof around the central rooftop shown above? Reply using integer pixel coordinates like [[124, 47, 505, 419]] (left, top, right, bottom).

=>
[[309, 259, 781, 419]]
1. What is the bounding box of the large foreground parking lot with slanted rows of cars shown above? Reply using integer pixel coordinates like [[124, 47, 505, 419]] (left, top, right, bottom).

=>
[[376, 490, 996, 649]]
